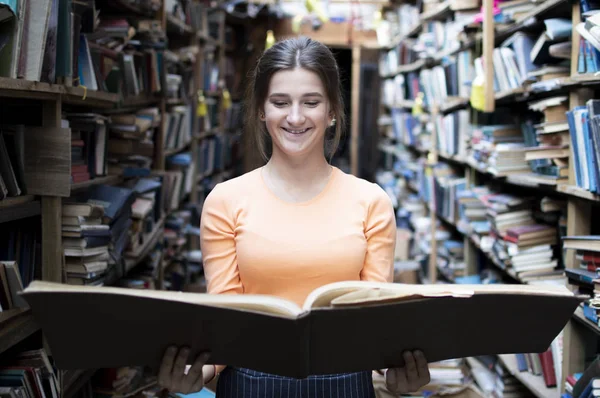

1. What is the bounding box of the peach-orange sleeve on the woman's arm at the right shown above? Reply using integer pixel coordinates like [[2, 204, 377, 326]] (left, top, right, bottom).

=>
[[361, 185, 396, 282]]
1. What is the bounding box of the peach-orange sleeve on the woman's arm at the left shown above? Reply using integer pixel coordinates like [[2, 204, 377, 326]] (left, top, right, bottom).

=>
[[200, 185, 243, 294]]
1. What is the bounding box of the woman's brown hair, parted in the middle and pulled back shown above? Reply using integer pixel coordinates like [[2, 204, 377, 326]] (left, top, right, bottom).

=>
[[245, 37, 346, 160]]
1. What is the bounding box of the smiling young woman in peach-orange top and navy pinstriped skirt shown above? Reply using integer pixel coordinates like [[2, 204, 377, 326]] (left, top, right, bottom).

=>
[[159, 38, 429, 398]]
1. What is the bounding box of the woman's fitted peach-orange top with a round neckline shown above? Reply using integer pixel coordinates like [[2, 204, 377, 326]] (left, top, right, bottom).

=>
[[200, 167, 396, 306]]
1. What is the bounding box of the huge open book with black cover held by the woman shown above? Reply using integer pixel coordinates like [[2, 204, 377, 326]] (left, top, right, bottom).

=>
[[22, 281, 585, 378]]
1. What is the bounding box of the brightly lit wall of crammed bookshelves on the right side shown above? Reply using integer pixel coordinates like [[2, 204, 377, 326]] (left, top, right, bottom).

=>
[[378, 0, 600, 397]]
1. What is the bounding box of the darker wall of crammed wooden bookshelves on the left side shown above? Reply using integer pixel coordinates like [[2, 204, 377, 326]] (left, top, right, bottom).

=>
[[0, 0, 248, 397]]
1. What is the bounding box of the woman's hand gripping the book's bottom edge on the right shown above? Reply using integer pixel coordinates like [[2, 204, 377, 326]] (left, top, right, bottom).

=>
[[385, 351, 431, 394]]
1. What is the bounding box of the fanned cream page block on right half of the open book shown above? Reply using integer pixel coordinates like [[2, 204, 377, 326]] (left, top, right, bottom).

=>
[[304, 281, 573, 311]]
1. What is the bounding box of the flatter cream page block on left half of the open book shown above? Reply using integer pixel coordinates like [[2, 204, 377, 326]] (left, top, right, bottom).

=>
[[24, 281, 302, 319]]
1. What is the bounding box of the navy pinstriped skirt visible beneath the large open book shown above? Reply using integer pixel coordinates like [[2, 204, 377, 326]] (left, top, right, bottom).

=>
[[217, 367, 375, 398]]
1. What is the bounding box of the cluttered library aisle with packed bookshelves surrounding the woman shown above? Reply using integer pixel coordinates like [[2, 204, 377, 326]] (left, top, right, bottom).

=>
[[0, 0, 600, 398]]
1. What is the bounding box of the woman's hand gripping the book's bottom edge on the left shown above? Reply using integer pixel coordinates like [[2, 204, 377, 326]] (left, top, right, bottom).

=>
[[158, 346, 209, 394]]
